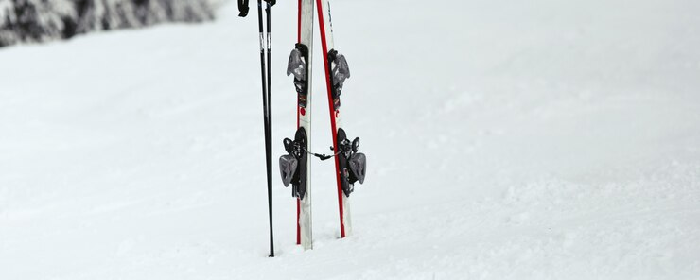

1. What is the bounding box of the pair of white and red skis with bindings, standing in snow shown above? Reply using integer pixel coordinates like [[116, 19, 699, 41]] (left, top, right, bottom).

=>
[[280, 0, 366, 250]]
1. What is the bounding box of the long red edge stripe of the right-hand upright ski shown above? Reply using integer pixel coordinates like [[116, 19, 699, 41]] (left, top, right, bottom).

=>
[[316, 0, 345, 238]]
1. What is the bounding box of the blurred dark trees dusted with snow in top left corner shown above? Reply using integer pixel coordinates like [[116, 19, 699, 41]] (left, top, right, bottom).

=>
[[0, 0, 213, 47]]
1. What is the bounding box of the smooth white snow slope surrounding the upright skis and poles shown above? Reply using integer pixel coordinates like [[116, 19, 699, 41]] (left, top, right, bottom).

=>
[[0, 0, 700, 280]]
